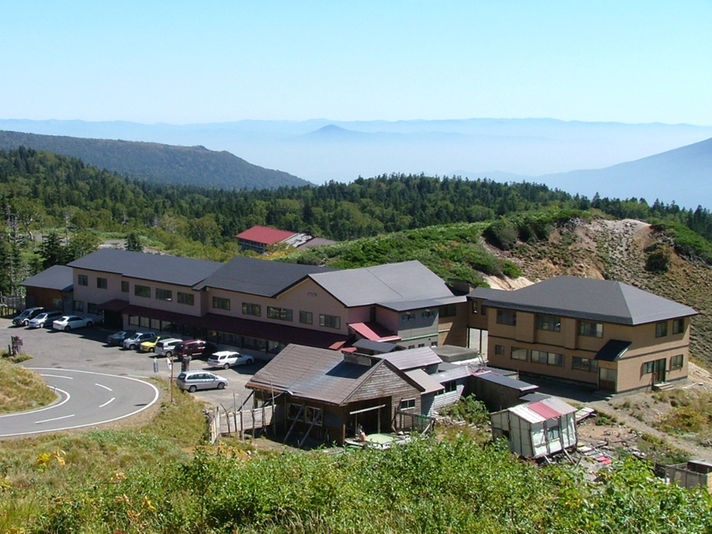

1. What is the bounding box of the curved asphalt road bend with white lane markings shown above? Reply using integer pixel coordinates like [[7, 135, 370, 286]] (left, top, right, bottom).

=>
[[0, 368, 159, 438]]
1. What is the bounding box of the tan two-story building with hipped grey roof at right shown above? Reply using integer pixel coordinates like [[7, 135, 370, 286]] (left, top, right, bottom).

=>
[[468, 276, 697, 392]]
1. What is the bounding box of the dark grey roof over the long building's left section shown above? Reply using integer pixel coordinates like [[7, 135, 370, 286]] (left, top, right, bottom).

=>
[[68, 248, 222, 286]]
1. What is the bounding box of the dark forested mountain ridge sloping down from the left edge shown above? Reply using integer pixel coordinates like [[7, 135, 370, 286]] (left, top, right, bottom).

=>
[[0, 131, 311, 189]]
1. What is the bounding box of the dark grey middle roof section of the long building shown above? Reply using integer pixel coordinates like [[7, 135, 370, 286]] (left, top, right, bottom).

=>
[[196, 256, 332, 297]]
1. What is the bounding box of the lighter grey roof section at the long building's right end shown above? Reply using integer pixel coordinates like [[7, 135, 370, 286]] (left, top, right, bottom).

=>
[[310, 261, 453, 309]]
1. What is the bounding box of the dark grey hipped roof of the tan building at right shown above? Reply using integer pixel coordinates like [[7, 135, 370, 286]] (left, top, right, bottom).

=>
[[470, 276, 697, 325]]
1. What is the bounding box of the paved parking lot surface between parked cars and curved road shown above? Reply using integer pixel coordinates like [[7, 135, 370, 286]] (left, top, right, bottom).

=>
[[0, 318, 263, 409]]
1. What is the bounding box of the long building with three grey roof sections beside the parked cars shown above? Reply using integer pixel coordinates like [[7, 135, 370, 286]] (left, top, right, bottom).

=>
[[69, 249, 467, 354]]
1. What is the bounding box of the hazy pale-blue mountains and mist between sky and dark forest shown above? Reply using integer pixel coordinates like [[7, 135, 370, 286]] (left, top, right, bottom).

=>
[[0, 119, 712, 208]]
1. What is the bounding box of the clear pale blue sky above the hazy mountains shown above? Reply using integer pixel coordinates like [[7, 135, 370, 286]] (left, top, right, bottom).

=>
[[0, 0, 712, 125]]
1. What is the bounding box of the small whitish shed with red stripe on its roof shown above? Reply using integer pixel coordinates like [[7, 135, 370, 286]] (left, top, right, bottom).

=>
[[490, 397, 578, 458]]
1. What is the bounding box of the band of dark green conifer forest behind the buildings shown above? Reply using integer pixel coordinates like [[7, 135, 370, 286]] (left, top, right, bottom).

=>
[[0, 147, 712, 294]]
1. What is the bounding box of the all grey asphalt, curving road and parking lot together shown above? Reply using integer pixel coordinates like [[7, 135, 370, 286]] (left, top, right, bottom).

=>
[[0, 319, 262, 437]]
